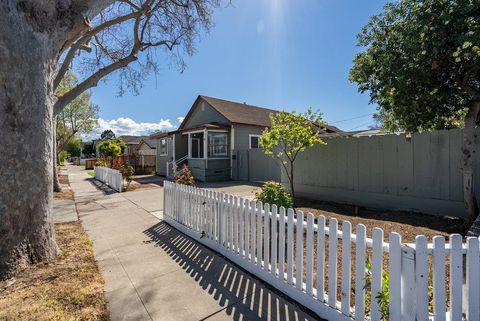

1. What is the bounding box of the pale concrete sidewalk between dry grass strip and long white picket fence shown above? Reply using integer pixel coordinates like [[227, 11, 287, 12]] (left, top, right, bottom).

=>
[[69, 166, 316, 321]]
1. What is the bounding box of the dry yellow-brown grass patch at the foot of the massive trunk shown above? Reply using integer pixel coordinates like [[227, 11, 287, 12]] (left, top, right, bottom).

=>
[[0, 222, 110, 320]]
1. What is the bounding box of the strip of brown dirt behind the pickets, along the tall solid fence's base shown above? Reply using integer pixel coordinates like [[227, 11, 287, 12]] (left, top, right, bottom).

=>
[[297, 200, 467, 243]]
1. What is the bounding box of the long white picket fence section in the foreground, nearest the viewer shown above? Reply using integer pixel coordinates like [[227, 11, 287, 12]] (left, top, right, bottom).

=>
[[164, 181, 480, 321]]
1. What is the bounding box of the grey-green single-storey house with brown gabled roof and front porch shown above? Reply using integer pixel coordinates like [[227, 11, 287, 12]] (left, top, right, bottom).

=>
[[150, 96, 340, 181]]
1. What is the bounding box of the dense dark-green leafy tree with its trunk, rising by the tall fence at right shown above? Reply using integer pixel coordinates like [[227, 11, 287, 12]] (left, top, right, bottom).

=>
[[350, 0, 480, 225]]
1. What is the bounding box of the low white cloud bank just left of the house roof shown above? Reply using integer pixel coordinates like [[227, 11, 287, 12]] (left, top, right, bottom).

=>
[[89, 117, 182, 138]]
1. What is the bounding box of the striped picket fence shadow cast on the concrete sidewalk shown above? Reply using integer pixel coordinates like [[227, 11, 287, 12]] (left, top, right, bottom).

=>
[[144, 222, 318, 321]]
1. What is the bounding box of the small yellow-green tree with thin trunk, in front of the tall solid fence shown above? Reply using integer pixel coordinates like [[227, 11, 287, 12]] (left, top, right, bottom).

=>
[[260, 109, 326, 203]]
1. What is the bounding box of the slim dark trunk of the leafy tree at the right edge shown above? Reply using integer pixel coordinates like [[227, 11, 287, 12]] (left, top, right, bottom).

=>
[[462, 101, 480, 228]]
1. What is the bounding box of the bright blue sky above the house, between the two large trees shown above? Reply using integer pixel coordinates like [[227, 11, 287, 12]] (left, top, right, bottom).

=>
[[92, 0, 385, 134]]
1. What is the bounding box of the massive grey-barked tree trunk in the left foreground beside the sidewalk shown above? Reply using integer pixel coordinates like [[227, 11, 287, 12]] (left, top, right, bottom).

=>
[[0, 0, 61, 279]]
